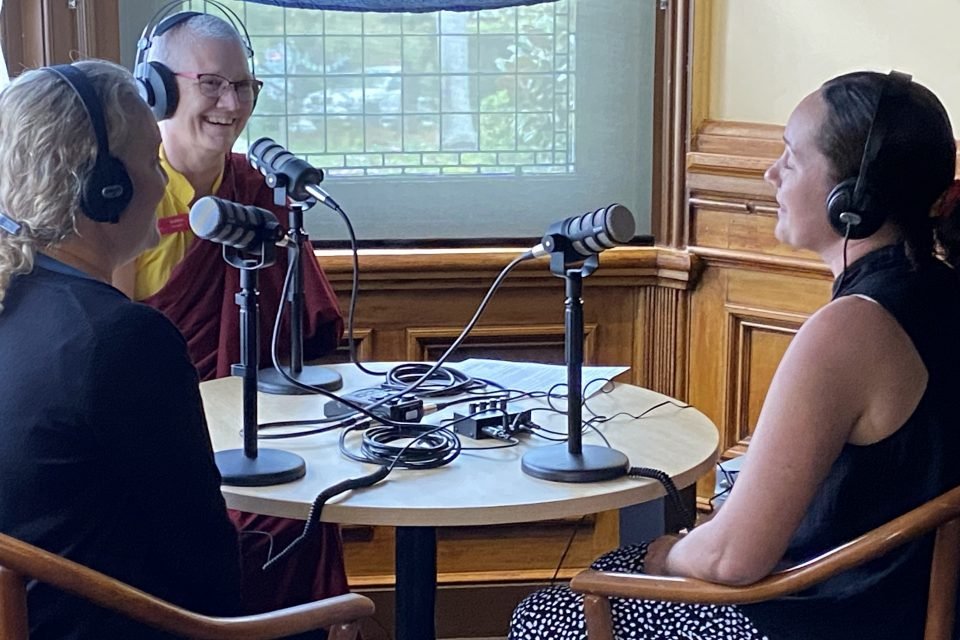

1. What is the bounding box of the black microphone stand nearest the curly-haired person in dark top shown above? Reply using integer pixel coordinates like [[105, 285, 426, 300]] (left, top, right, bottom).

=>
[[214, 242, 307, 487]]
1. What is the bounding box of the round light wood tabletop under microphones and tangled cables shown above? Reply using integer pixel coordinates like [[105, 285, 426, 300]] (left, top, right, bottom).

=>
[[200, 365, 719, 527]]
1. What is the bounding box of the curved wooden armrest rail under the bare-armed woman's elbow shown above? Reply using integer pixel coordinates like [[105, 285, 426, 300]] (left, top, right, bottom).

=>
[[570, 487, 960, 604]]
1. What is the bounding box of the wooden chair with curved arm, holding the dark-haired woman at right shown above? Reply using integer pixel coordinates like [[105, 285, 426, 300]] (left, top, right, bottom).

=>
[[570, 487, 960, 640]]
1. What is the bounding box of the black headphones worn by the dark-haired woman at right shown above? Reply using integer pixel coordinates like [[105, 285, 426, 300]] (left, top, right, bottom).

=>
[[827, 71, 912, 239]]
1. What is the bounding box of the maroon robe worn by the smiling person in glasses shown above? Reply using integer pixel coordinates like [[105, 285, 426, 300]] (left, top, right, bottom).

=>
[[143, 153, 347, 613]]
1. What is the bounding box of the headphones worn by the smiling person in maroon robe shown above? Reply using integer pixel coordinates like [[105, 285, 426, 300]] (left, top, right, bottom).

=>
[[133, 0, 253, 120]]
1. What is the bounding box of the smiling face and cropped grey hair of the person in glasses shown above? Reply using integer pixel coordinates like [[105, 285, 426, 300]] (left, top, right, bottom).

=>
[[161, 30, 253, 166]]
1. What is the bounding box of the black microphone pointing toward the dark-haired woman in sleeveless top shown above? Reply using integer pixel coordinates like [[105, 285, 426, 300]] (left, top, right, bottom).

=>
[[527, 204, 636, 259]]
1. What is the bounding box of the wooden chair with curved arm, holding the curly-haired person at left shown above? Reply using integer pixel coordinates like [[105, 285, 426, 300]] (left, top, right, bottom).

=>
[[0, 534, 373, 640]]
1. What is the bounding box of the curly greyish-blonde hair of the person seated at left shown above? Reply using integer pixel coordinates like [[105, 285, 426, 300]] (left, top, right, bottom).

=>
[[0, 60, 140, 311]]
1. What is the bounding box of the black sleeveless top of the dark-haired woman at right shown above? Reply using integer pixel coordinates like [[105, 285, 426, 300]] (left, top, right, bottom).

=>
[[742, 245, 960, 640]]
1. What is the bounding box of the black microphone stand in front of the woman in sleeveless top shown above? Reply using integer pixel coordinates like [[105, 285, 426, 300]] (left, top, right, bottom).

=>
[[520, 242, 630, 482]]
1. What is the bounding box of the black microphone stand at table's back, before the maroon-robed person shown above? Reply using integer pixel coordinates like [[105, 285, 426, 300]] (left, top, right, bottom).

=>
[[257, 180, 343, 395]]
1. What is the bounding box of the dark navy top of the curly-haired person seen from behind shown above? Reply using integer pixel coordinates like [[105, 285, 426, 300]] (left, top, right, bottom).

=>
[[0, 256, 240, 640]]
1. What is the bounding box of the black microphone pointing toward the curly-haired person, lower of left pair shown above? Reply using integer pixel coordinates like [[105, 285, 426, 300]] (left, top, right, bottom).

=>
[[190, 196, 289, 251]]
